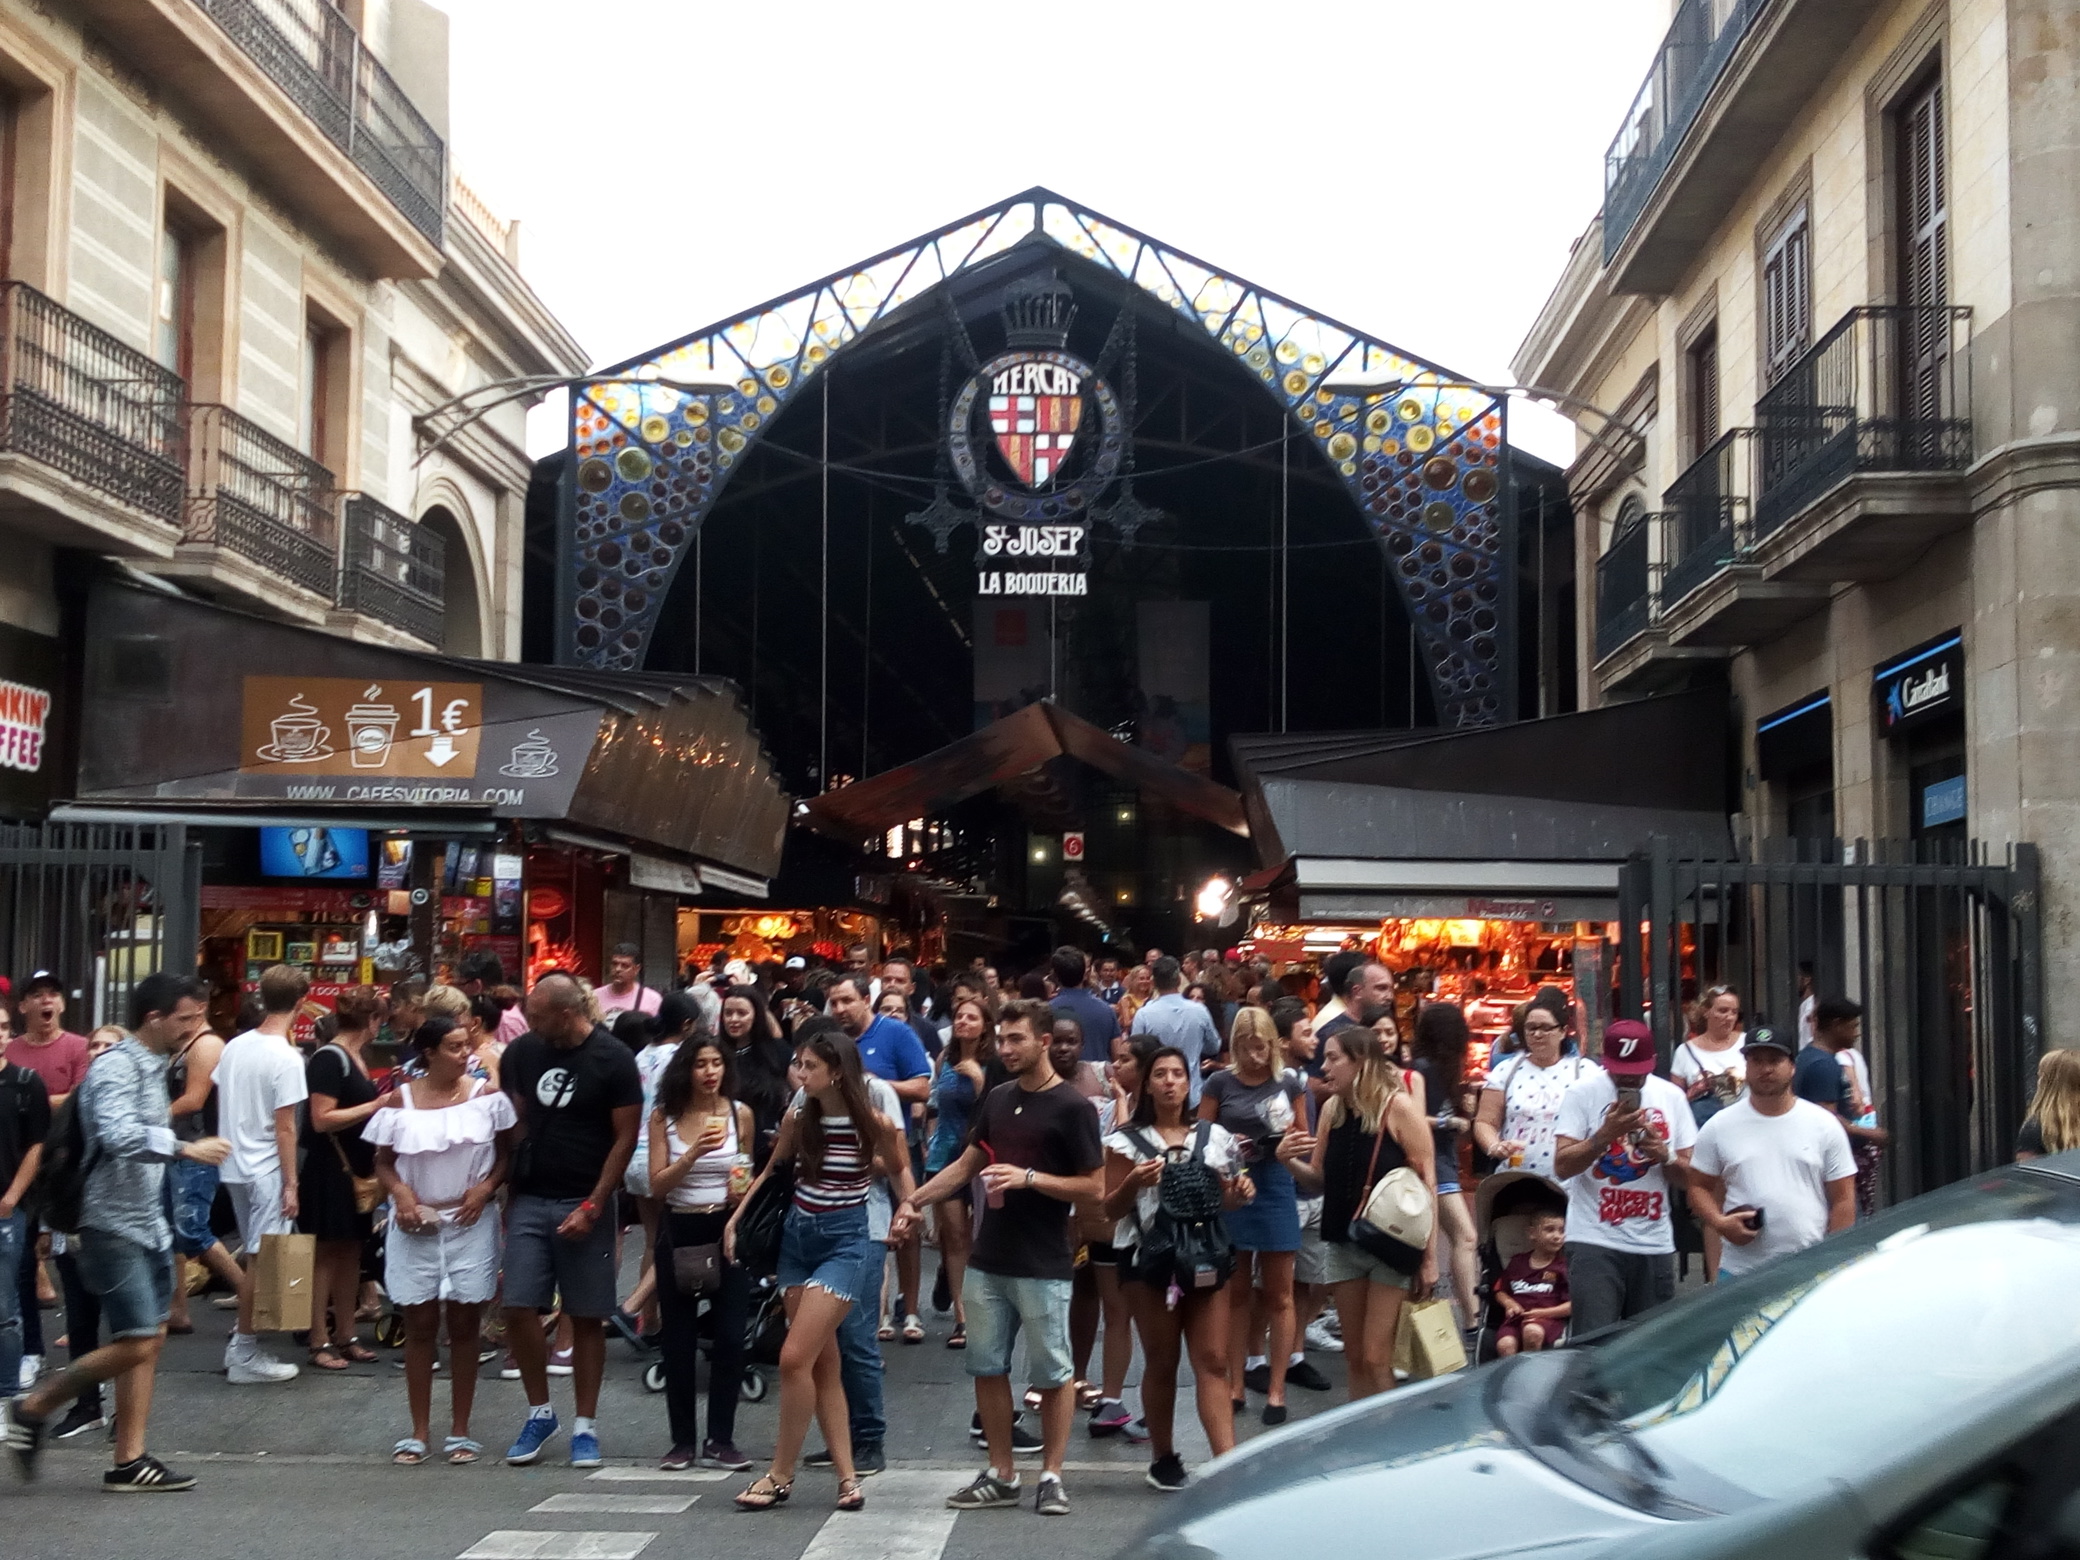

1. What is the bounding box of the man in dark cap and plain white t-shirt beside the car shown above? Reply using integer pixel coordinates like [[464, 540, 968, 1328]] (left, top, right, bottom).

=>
[[1689, 1023, 1855, 1279]]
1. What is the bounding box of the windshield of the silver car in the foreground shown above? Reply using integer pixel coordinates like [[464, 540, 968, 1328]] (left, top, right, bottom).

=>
[[1560, 1171, 2080, 1510]]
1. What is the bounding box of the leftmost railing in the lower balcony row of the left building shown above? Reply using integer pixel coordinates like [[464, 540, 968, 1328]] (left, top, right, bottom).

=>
[[0, 281, 185, 524]]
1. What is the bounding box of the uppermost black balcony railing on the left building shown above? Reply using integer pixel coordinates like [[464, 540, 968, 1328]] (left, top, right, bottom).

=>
[[196, 0, 447, 243]]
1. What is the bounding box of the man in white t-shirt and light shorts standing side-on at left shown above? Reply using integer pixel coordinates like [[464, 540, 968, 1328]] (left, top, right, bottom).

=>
[[216, 965, 310, 1387]]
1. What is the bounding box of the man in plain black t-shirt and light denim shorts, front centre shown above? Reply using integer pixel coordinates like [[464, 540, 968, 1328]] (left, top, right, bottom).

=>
[[890, 1003, 1104, 1516]]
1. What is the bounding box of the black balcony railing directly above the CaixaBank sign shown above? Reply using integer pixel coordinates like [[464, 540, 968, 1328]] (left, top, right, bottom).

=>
[[1756, 304, 1972, 541]]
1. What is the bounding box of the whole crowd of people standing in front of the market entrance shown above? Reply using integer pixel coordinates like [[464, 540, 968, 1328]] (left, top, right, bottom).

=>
[[0, 946, 2080, 1514]]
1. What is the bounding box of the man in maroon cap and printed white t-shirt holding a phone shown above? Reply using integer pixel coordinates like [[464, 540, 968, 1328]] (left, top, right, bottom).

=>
[[1554, 1019, 1697, 1337]]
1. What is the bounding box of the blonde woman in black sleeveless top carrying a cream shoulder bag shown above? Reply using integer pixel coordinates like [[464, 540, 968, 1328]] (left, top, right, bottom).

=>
[[1279, 1023, 1437, 1402]]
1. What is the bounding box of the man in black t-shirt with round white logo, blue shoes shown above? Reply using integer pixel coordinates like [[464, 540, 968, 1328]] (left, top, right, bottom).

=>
[[499, 976, 643, 1468]]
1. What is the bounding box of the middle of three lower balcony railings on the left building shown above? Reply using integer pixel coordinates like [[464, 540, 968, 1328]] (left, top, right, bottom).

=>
[[183, 406, 339, 599]]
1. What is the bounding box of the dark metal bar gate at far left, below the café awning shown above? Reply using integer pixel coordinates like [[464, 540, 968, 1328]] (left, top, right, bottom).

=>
[[0, 824, 202, 1030]]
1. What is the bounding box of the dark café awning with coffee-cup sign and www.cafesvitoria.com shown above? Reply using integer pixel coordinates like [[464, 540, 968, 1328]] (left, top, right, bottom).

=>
[[71, 578, 790, 880]]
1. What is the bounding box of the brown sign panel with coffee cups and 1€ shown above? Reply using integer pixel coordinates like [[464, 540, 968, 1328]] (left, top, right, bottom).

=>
[[239, 678, 485, 780]]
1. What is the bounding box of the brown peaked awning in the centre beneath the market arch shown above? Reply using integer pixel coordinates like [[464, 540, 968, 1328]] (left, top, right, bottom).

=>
[[809, 701, 1250, 840]]
